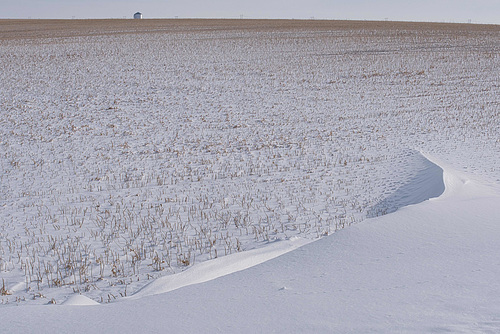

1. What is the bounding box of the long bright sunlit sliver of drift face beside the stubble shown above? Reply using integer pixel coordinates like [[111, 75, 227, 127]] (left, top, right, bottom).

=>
[[130, 237, 311, 299]]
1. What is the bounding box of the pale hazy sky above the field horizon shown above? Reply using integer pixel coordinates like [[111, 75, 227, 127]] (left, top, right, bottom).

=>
[[0, 0, 500, 24]]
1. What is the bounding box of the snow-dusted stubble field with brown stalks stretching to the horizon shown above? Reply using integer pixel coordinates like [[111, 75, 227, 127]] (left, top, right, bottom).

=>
[[0, 19, 500, 305]]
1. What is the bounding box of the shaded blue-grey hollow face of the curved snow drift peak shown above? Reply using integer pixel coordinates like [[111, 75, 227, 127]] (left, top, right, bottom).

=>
[[367, 153, 445, 218]]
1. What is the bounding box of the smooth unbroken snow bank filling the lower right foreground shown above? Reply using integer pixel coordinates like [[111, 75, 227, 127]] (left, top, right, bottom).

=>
[[0, 157, 500, 333]]
